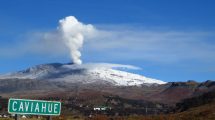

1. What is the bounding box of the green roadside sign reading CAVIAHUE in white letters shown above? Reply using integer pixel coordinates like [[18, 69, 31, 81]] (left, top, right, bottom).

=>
[[8, 98, 61, 116]]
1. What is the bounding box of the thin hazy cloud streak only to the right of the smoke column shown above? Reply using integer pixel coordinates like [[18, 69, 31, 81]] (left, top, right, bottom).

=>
[[85, 28, 215, 63]]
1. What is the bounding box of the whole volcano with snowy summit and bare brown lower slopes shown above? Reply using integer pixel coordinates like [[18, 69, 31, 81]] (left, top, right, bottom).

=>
[[0, 63, 215, 105]]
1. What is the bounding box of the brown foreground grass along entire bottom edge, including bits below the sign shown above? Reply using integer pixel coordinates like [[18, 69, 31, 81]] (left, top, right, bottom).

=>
[[0, 103, 215, 120]]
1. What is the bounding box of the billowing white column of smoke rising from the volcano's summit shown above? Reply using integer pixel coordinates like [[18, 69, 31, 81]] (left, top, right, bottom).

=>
[[58, 16, 95, 64]]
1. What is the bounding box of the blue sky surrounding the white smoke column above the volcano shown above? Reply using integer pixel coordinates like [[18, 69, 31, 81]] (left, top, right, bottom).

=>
[[0, 0, 215, 81]]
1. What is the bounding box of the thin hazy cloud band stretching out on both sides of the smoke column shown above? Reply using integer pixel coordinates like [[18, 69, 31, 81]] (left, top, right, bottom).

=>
[[0, 25, 215, 63]]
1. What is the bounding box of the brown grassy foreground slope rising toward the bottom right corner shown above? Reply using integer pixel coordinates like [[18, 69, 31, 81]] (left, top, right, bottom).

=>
[[91, 103, 215, 120]]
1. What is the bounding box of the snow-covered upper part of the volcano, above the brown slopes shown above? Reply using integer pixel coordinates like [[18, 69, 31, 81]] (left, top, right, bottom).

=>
[[0, 63, 165, 86]]
